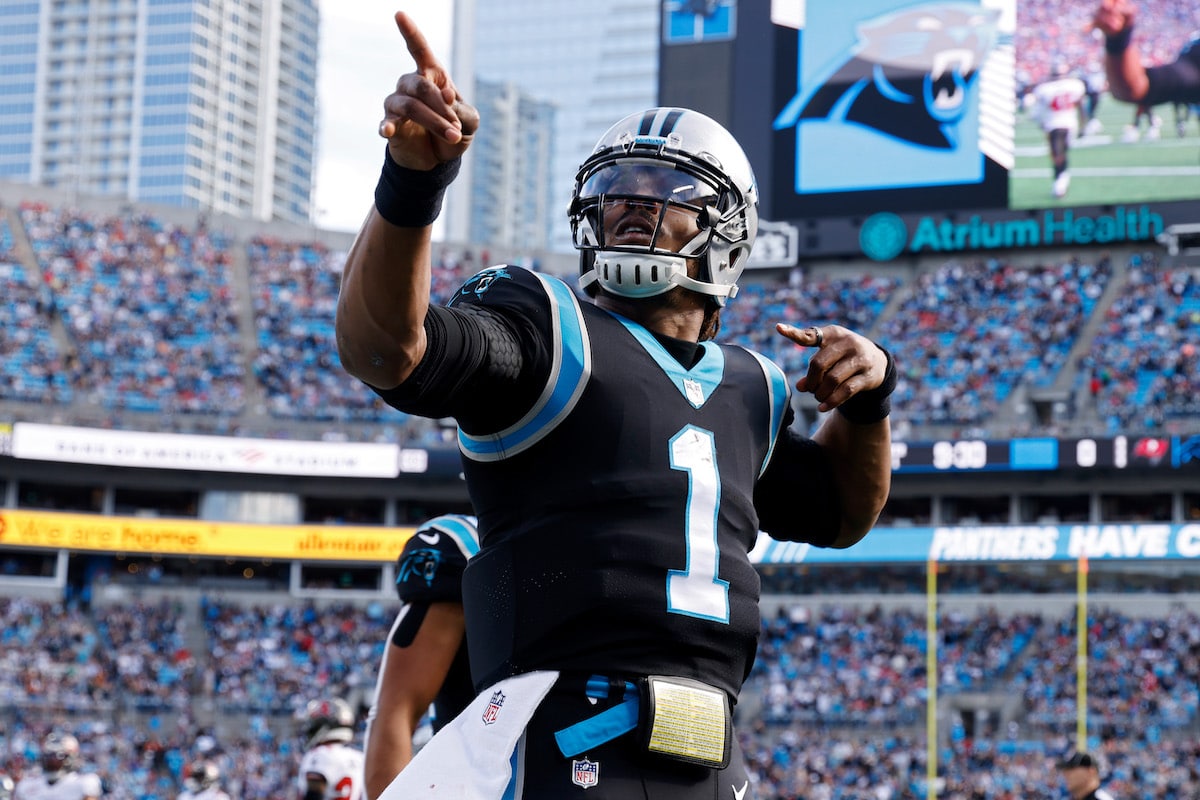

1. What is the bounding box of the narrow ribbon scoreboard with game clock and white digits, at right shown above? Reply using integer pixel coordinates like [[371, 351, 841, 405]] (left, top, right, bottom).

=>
[[892, 434, 1200, 474]]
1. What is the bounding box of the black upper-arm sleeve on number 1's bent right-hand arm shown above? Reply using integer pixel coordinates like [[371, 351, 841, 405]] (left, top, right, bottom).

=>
[[754, 427, 841, 547]]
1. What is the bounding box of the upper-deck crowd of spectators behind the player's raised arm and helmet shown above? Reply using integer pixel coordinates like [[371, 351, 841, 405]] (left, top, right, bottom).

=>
[[0, 196, 1200, 446]]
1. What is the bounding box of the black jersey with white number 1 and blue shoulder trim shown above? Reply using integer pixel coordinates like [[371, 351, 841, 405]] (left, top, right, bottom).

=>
[[436, 267, 790, 697]]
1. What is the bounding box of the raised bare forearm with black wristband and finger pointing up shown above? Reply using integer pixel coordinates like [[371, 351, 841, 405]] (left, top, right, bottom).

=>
[[335, 12, 479, 389]]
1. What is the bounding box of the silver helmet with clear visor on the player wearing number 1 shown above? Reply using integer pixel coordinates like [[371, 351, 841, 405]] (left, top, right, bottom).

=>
[[569, 108, 758, 306]]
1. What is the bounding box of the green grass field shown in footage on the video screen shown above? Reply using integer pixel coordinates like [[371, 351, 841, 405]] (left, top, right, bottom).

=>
[[1008, 96, 1200, 209]]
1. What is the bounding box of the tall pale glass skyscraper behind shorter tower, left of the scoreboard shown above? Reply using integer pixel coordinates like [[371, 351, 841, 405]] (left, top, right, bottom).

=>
[[446, 0, 662, 252]]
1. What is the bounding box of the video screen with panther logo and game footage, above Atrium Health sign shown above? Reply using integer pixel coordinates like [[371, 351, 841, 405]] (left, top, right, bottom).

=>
[[720, 0, 1200, 219]]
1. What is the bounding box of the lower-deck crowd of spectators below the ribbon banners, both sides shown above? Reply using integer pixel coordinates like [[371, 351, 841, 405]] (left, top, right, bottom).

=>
[[0, 597, 1200, 800]]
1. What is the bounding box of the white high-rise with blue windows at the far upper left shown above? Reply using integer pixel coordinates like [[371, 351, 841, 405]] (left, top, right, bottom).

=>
[[0, 0, 319, 223]]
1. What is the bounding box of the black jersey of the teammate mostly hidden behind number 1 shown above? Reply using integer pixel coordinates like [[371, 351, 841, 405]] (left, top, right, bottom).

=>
[[396, 515, 479, 730]]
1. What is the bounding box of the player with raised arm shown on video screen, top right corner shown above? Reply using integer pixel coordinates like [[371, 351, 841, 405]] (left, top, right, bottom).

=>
[[1093, 0, 1200, 108]]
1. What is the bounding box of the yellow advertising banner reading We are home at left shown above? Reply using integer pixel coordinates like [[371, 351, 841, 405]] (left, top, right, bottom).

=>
[[0, 509, 414, 563]]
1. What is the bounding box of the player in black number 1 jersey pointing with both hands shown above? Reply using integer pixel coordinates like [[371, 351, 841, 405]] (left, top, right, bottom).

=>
[[336, 13, 896, 800]]
